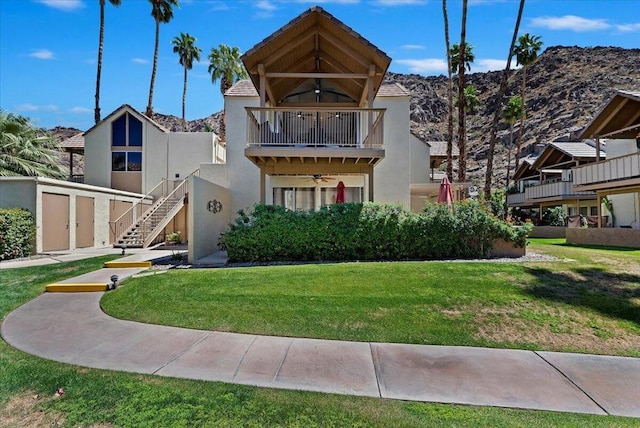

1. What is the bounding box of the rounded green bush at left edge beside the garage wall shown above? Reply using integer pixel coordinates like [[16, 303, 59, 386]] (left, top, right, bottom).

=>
[[0, 208, 36, 260]]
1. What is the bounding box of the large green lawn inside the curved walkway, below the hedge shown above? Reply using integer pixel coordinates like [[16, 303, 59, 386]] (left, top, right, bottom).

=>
[[102, 240, 640, 356]]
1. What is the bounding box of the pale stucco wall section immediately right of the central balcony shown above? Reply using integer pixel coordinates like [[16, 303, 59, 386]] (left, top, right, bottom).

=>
[[373, 96, 412, 207]]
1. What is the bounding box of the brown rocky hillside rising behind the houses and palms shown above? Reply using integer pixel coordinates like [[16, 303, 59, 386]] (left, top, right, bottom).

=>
[[50, 46, 640, 185]]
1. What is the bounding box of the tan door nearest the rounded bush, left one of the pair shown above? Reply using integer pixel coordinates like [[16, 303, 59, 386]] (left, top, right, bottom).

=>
[[42, 193, 69, 251]]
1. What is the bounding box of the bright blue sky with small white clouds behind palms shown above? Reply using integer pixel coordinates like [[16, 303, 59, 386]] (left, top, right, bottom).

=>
[[0, 0, 640, 130]]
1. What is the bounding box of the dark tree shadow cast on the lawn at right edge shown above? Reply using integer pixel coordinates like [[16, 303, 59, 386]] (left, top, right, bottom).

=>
[[525, 267, 640, 326]]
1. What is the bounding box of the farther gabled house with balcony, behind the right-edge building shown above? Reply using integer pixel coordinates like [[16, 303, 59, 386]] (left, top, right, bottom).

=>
[[507, 141, 606, 224]]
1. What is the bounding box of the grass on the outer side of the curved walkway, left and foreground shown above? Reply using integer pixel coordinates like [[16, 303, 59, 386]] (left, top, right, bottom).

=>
[[0, 249, 637, 427]]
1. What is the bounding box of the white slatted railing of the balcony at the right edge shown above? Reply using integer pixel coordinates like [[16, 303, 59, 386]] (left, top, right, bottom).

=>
[[573, 152, 640, 186]]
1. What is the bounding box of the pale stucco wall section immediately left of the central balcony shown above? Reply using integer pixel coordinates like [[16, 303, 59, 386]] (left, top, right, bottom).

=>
[[225, 96, 260, 213]]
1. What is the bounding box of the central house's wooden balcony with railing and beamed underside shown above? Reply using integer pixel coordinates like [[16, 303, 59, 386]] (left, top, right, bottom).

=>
[[245, 107, 385, 169]]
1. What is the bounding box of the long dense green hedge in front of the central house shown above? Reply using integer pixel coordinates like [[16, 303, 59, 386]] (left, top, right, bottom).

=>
[[223, 201, 532, 262]]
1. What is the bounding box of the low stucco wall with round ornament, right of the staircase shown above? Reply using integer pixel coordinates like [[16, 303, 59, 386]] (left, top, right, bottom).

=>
[[187, 176, 232, 263]]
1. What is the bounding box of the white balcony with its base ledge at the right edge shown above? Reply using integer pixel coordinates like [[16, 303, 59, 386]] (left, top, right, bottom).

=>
[[574, 152, 640, 190]]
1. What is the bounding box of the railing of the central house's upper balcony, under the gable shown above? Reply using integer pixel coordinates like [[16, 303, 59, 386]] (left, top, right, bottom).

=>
[[246, 107, 385, 149]]
